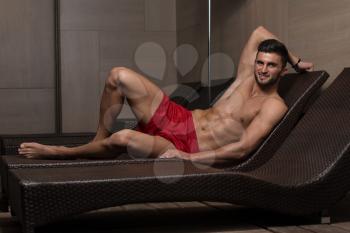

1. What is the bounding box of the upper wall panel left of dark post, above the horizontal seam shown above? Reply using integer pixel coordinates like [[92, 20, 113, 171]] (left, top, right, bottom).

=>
[[0, 0, 55, 88]]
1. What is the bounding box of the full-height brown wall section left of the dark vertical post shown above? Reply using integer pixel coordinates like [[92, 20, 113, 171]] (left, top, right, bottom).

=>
[[0, 0, 56, 134]]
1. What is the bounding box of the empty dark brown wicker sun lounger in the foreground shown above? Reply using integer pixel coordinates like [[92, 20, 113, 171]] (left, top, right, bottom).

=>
[[4, 69, 350, 233]]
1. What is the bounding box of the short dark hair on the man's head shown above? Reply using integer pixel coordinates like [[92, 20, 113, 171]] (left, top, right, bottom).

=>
[[258, 39, 289, 67]]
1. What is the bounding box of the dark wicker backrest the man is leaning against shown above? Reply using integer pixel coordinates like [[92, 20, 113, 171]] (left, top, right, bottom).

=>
[[232, 71, 329, 171]]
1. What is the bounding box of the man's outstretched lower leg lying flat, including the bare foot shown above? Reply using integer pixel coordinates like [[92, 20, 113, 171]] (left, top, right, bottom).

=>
[[19, 129, 175, 159]]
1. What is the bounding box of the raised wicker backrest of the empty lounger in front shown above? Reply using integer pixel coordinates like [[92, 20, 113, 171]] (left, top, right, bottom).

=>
[[247, 68, 350, 186]]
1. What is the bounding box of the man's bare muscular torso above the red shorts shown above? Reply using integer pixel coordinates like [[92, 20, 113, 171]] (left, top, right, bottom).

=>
[[192, 80, 283, 151]]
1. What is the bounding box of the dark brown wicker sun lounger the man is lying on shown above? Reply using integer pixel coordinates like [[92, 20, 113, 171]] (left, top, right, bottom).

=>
[[0, 71, 328, 215]]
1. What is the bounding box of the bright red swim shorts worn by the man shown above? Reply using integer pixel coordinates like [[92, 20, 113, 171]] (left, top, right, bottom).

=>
[[137, 94, 199, 153]]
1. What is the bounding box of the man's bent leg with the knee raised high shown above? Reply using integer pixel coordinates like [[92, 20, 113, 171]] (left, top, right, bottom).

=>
[[94, 67, 163, 141]]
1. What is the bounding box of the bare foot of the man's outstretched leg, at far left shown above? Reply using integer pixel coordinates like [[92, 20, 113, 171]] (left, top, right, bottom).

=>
[[18, 142, 67, 159]]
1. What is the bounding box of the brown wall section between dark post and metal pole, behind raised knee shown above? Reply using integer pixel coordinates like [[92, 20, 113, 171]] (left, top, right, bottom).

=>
[[60, 0, 208, 133]]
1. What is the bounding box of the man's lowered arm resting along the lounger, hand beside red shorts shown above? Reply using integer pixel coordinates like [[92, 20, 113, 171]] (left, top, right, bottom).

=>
[[160, 98, 287, 164]]
